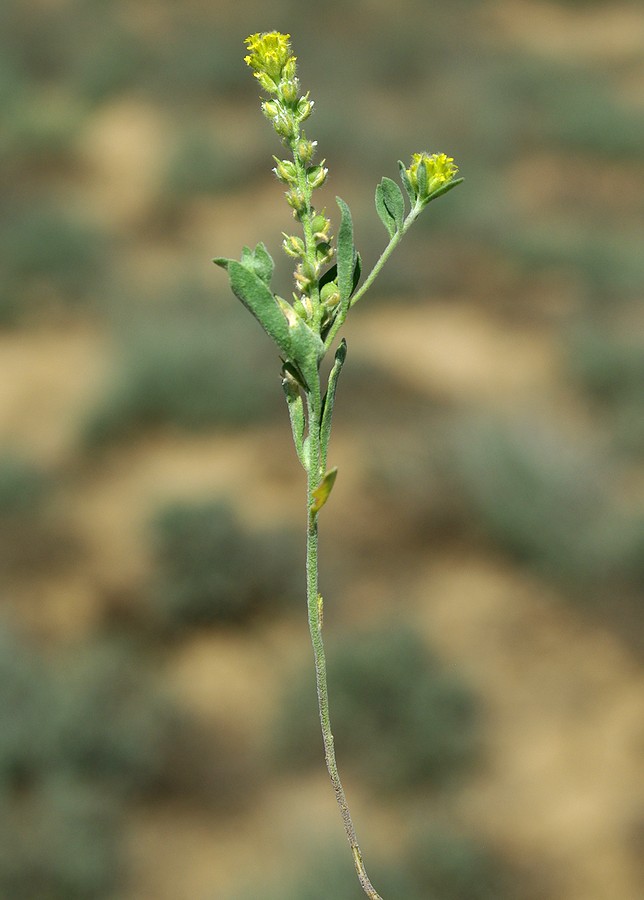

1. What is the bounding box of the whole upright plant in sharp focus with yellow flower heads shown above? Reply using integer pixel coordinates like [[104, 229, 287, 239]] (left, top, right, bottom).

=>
[[214, 31, 463, 900]]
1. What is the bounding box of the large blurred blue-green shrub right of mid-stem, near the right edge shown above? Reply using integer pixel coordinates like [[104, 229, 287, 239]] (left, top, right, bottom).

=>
[[451, 420, 608, 579]]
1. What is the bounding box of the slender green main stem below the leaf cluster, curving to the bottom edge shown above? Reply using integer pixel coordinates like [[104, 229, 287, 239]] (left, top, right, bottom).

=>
[[306, 381, 382, 900]]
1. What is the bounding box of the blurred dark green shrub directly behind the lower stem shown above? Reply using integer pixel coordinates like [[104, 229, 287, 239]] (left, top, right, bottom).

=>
[[275, 627, 479, 790]]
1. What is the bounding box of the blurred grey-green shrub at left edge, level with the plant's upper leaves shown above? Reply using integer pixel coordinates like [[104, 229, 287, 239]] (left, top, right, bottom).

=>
[[0, 206, 104, 324]]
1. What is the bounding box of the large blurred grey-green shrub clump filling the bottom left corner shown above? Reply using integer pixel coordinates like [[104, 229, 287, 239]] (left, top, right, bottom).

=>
[[0, 625, 191, 900]]
